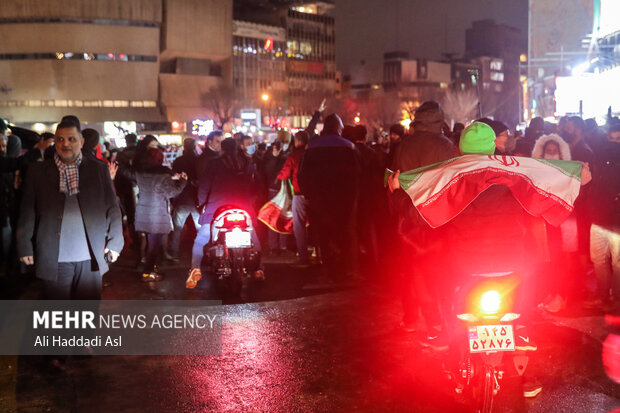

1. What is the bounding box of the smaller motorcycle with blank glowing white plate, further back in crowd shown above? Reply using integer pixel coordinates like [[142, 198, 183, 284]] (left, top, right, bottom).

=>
[[203, 205, 264, 299]]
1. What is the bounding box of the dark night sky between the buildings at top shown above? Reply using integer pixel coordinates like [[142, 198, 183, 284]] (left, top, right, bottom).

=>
[[335, 0, 528, 83]]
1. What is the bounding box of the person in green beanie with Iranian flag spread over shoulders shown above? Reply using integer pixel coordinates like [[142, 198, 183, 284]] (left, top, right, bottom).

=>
[[387, 122, 592, 396]]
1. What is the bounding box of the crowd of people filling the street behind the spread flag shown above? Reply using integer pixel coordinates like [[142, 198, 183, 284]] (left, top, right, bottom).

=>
[[0, 102, 620, 327]]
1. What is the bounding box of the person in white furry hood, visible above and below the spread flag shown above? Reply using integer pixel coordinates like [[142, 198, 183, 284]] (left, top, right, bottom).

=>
[[532, 134, 579, 313]]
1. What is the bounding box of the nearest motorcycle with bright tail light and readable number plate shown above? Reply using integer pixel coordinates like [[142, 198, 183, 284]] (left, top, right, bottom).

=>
[[453, 274, 529, 413]]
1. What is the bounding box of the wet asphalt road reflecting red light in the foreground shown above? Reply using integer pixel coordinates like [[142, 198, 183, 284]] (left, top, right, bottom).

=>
[[0, 254, 620, 413]]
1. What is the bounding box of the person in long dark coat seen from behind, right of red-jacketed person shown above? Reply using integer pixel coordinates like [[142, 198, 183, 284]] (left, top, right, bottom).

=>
[[298, 114, 361, 281]]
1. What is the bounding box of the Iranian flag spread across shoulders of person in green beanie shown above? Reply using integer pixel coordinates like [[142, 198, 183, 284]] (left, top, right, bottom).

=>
[[386, 155, 582, 228]]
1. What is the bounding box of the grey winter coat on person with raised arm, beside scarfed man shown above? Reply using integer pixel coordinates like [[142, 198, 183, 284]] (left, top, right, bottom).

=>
[[135, 166, 187, 234]]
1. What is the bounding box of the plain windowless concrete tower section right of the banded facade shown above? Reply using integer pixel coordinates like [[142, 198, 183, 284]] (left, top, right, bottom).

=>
[[159, 0, 233, 122]]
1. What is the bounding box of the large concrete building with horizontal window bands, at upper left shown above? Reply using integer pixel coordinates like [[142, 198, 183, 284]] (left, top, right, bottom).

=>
[[0, 0, 232, 134]]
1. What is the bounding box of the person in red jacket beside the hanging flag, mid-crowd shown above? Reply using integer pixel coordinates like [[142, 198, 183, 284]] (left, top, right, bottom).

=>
[[278, 131, 310, 265]]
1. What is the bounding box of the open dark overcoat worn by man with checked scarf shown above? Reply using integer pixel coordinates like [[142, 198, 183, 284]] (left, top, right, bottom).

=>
[[17, 157, 124, 280]]
